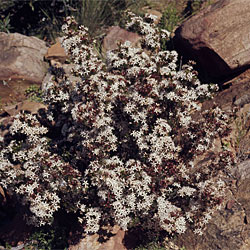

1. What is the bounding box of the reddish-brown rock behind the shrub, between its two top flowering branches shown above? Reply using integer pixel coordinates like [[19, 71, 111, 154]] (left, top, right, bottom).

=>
[[103, 26, 140, 52]]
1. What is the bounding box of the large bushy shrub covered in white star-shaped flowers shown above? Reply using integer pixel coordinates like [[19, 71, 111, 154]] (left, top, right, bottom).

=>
[[0, 14, 234, 234]]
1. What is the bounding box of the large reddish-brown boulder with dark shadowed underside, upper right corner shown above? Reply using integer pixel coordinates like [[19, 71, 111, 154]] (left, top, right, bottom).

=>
[[174, 0, 250, 78]]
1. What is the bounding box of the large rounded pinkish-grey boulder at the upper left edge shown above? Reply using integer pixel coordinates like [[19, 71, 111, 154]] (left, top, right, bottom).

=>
[[0, 32, 48, 84]]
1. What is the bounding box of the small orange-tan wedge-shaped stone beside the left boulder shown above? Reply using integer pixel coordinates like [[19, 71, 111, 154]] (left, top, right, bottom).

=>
[[45, 38, 68, 63]]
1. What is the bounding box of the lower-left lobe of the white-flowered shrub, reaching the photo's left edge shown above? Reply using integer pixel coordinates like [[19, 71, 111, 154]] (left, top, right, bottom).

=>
[[0, 113, 88, 226]]
